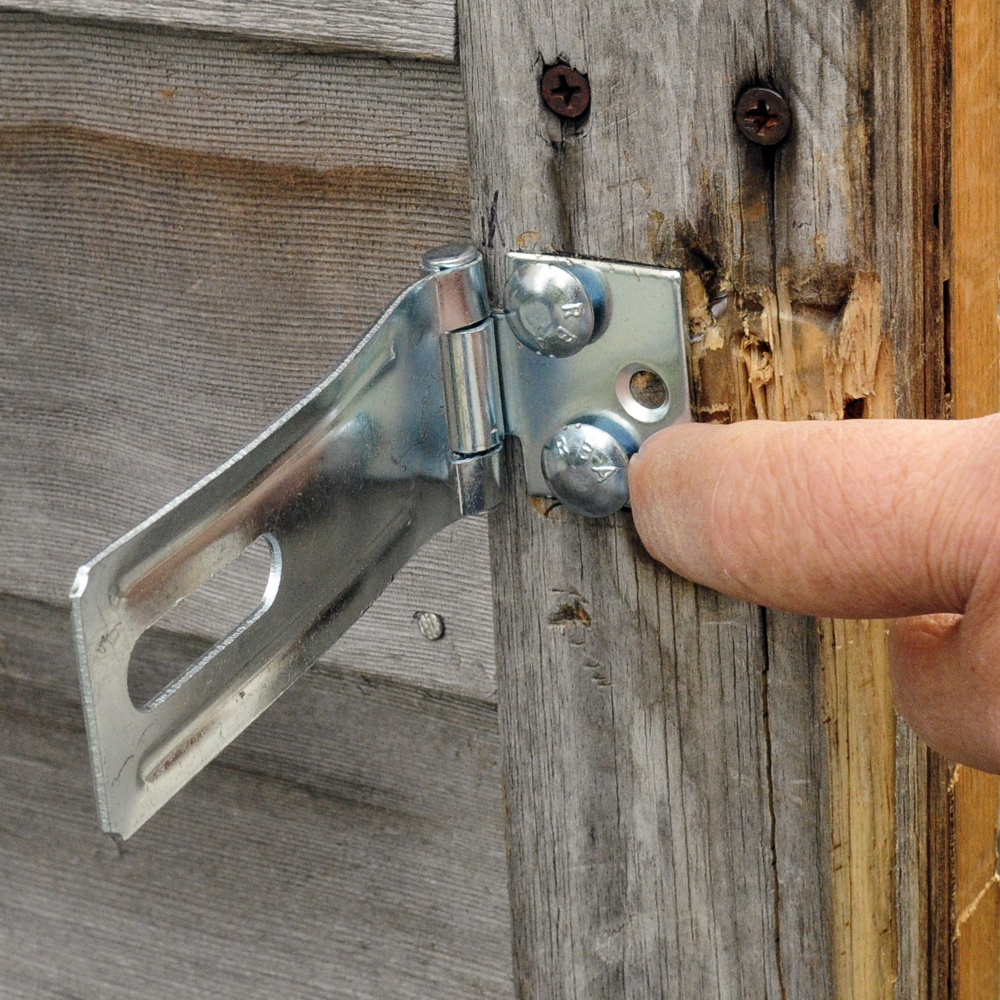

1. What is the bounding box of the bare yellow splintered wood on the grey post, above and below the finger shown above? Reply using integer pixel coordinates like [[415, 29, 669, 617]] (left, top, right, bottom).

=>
[[685, 271, 897, 1000]]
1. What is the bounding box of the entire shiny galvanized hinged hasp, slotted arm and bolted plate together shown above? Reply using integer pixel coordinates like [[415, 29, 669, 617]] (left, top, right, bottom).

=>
[[70, 245, 689, 837]]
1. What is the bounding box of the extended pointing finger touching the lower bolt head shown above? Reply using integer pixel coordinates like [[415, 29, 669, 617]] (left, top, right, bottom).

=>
[[629, 417, 1000, 618]]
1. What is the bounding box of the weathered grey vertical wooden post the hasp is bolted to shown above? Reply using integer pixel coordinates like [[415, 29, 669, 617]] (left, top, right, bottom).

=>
[[459, 0, 925, 1000]]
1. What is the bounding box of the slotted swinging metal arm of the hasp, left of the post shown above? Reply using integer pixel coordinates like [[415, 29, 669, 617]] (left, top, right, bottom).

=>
[[71, 250, 500, 837]]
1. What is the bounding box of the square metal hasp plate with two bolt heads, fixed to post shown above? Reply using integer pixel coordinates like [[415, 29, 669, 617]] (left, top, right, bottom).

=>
[[497, 253, 691, 517]]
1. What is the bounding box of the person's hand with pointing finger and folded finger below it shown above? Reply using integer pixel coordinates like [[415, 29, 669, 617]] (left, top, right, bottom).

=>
[[629, 415, 1000, 772]]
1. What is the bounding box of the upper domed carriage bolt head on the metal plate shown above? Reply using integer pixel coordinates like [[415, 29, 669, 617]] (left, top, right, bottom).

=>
[[504, 261, 596, 358]]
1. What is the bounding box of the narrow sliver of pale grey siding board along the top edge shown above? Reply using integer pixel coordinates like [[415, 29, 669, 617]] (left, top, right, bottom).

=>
[[0, 0, 455, 62]]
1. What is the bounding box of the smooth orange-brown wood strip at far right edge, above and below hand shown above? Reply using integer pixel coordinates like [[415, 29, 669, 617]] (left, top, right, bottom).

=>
[[947, 0, 1000, 1000]]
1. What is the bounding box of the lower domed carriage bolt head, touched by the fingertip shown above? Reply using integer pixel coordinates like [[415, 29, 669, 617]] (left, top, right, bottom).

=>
[[542, 423, 629, 517]]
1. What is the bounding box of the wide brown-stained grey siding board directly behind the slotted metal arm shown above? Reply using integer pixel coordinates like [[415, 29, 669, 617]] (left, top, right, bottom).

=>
[[0, 14, 494, 697]]
